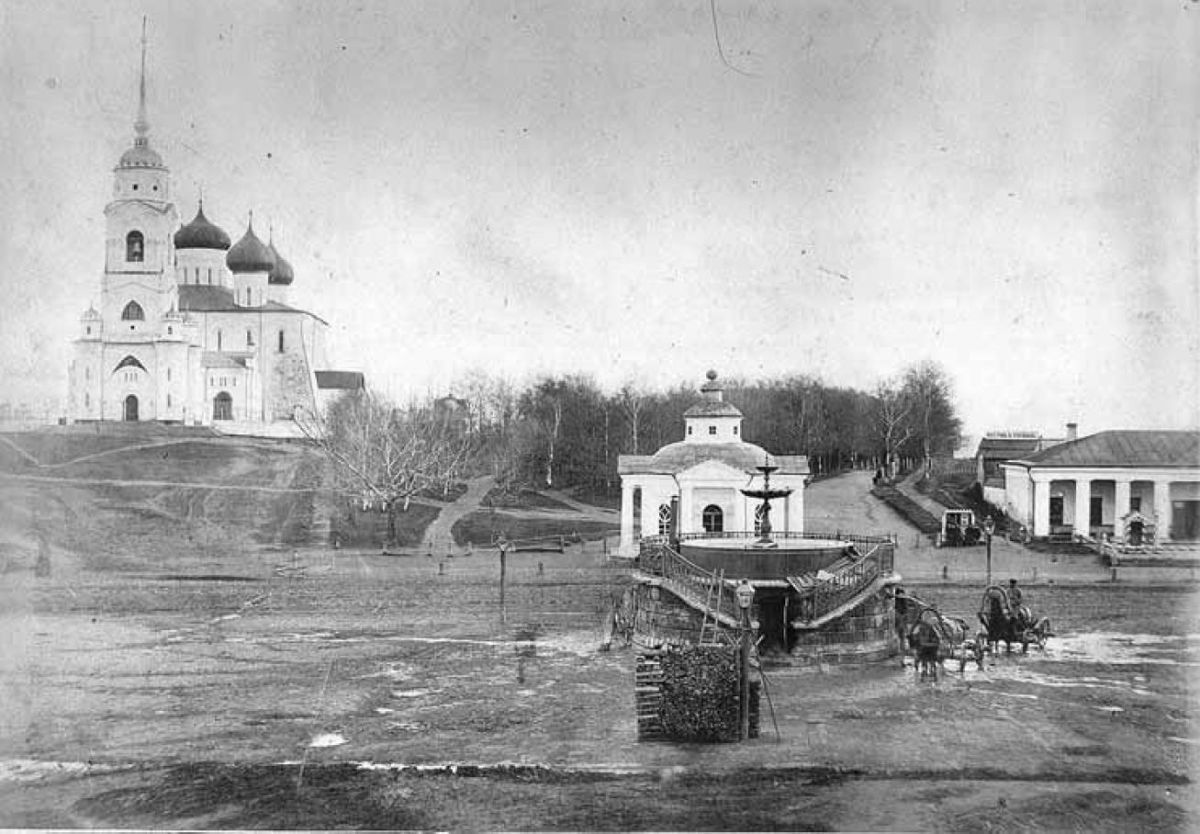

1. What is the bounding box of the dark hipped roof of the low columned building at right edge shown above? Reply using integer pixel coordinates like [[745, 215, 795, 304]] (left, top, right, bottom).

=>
[[1016, 430, 1200, 469]]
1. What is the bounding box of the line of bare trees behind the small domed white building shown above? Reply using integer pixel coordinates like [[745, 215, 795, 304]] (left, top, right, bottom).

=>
[[298, 361, 961, 528]]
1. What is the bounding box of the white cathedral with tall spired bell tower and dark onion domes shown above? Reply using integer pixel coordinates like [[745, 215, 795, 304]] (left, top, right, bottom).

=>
[[67, 40, 364, 434]]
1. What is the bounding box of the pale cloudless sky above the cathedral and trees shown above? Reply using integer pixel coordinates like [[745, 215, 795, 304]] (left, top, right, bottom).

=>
[[0, 0, 1200, 434]]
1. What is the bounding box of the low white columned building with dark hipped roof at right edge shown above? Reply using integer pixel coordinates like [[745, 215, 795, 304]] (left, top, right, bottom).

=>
[[1000, 431, 1200, 541]]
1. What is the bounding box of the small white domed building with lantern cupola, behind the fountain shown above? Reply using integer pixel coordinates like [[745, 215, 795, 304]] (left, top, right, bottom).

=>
[[617, 371, 809, 557]]
